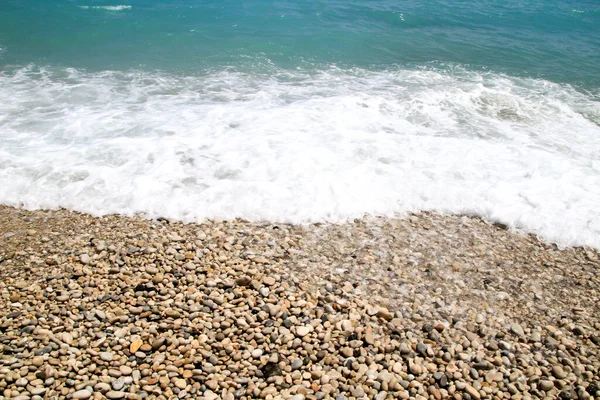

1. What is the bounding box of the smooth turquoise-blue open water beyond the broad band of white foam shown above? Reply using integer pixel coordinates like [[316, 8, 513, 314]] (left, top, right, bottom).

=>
[[0, 0, 600, 91]]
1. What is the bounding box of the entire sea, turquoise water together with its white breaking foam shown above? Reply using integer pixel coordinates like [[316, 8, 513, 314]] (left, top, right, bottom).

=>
[[0, 0, 600, 248]]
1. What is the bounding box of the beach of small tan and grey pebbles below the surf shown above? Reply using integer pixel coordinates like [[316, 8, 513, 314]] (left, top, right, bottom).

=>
[[0, 207, 600, 400]]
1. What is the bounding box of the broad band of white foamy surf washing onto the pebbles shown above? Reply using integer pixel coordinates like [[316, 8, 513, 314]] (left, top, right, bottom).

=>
[[0, 67, 600, 248]]
